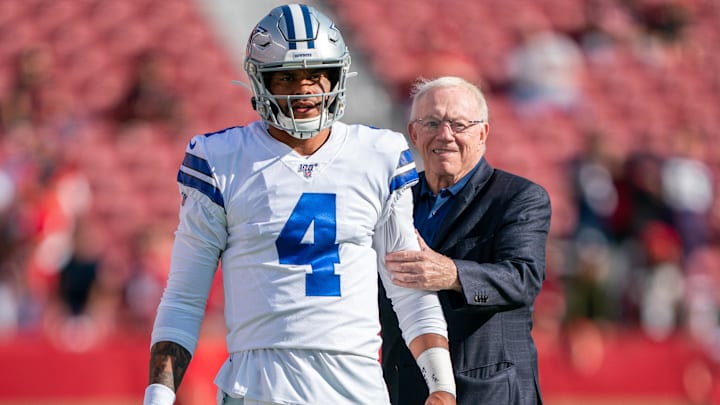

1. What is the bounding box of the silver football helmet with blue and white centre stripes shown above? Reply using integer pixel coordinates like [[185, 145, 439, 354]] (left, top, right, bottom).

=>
[[245, 4, 350, 139]]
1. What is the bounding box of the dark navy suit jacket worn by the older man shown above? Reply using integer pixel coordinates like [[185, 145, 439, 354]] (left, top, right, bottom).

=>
[[379, 158, 550, 405]]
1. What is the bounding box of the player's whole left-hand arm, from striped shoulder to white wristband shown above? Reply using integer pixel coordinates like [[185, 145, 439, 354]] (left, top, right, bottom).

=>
[[144, 138, 227, 405]]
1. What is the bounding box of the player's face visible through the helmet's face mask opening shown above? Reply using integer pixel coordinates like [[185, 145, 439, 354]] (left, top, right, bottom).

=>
[[268, 69, 332, 118]]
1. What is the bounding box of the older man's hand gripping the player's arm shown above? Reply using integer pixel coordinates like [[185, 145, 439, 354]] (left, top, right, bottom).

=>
[[385, 230, 461, 291]]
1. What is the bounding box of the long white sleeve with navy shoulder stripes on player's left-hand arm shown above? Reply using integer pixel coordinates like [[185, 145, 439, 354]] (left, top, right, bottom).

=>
[[151, 137, 227, 353]]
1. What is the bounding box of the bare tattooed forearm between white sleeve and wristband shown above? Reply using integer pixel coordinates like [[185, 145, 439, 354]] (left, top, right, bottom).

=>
[[150, 342, 192, 391]]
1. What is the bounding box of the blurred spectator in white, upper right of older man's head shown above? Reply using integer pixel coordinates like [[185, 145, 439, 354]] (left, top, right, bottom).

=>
[[507, 14, 585, 116]]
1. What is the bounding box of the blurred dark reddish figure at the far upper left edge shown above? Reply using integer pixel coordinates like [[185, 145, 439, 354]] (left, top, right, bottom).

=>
[[0, 45, 53, 133]]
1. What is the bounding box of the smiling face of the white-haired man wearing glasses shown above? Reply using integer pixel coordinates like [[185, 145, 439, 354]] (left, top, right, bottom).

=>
[[408, 87, 490, 188]]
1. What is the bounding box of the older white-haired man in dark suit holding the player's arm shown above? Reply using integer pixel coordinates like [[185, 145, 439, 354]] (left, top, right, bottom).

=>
[[380, 77, 551, 405]]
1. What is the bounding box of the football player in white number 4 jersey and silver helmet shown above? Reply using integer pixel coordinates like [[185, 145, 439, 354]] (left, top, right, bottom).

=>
[[145, 4, 455, 405]]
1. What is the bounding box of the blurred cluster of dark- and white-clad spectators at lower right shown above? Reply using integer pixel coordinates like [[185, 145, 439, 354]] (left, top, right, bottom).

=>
[[555, 126, 720, 348]]
